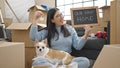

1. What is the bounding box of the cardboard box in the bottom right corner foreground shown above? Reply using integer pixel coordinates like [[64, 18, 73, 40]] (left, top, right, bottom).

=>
[[93, 44, 120, 68]]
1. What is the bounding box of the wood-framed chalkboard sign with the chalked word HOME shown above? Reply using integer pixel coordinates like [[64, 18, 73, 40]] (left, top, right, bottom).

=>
[[71, 6, 99, 27]]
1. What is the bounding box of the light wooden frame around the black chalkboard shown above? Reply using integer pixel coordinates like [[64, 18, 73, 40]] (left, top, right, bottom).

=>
[[70, 6, 100, 27]]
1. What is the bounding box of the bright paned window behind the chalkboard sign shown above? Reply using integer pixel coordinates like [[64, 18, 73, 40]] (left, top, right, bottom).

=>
[[56, 0, 111, 20]]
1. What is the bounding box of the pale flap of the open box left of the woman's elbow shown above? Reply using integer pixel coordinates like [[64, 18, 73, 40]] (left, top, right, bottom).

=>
[[7, 23, 32, 30]]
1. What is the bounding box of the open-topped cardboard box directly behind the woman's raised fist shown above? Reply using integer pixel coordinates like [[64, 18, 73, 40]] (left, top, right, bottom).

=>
[[28, 5, 47, 24]]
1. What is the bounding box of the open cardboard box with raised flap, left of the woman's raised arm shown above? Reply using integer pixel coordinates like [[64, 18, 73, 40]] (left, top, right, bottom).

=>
[[7, 23, 33, 47]]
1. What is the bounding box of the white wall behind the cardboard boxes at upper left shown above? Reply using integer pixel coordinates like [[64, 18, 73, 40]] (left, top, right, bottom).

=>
[[5, 0, 55, 23]]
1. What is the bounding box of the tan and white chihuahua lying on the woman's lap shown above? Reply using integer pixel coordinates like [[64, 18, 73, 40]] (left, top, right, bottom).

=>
[[33, 40, 74, 66]]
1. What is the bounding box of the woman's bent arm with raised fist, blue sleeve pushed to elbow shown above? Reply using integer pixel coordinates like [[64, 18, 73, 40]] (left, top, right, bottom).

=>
[[30, 11, 47, 41]]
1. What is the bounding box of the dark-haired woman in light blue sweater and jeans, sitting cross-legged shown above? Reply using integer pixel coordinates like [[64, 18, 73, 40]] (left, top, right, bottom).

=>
[[30, 8, 91, 68]]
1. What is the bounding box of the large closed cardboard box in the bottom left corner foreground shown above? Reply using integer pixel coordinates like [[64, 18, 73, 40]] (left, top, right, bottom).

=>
[[0, 42, 25, 68]]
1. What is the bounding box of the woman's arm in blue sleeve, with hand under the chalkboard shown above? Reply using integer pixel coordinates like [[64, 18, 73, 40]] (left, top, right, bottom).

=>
[[72, 26, 91, 50]]
